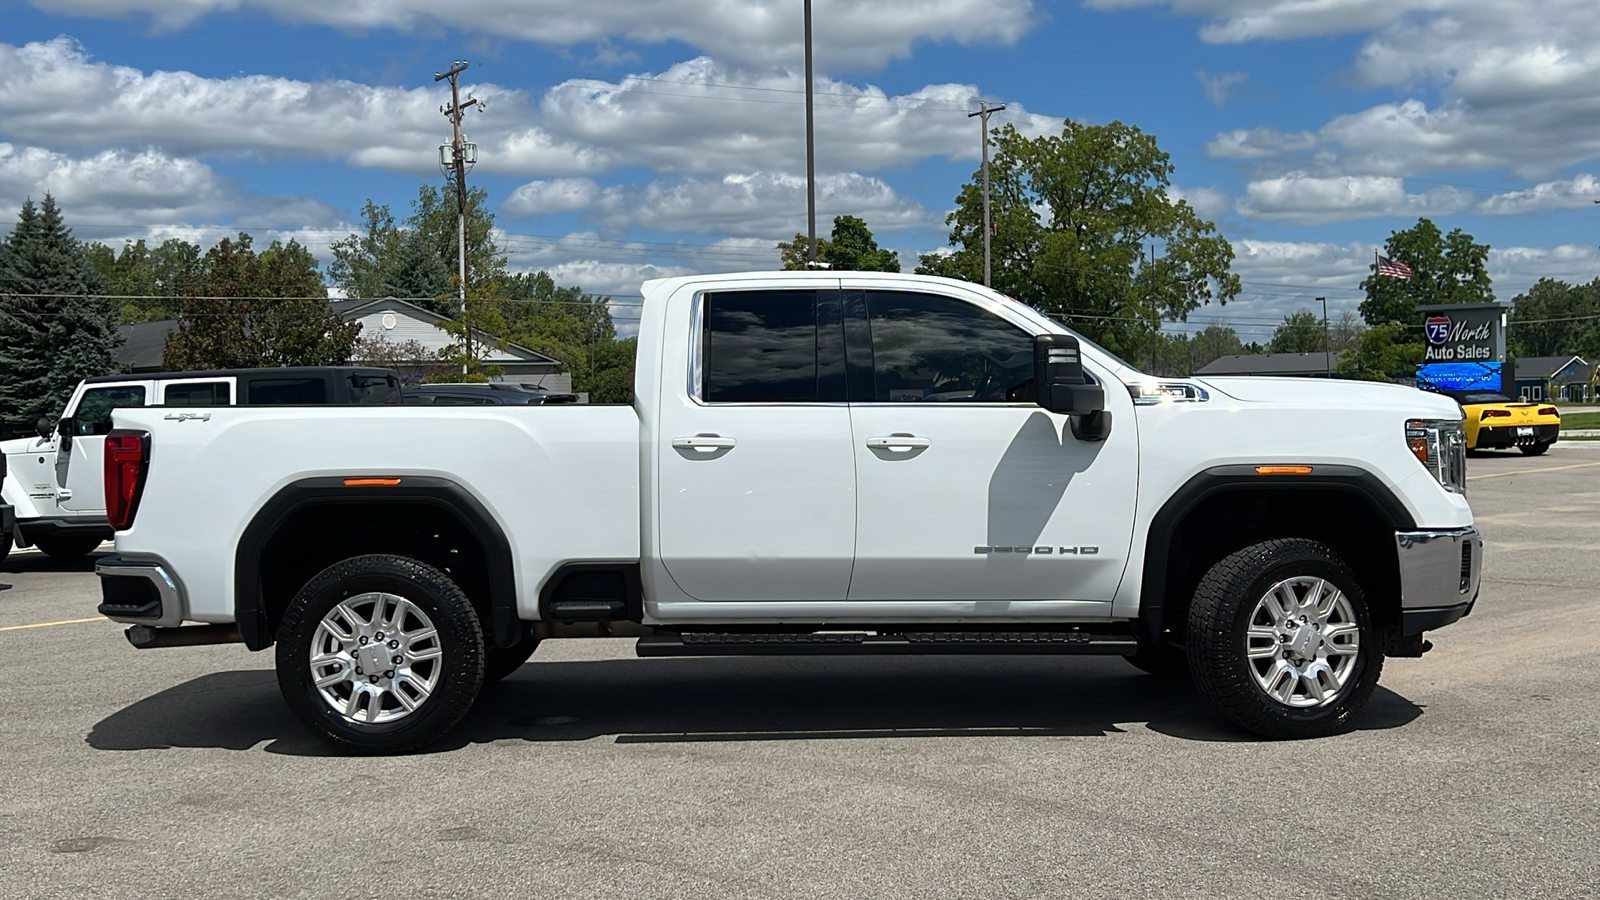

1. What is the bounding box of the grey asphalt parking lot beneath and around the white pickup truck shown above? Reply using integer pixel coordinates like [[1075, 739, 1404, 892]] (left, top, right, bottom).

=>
[[0, 442, 1600, 900]]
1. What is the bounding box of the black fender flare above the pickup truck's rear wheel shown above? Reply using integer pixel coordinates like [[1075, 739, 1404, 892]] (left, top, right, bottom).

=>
[[234, 472, 522, 650]]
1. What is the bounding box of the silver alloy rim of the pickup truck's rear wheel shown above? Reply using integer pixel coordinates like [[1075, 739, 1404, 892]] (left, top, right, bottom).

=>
[[310, 593, 445, 725]]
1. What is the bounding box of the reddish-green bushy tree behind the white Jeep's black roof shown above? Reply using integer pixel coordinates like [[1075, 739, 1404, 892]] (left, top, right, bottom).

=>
[[162, 232, 362, 372]]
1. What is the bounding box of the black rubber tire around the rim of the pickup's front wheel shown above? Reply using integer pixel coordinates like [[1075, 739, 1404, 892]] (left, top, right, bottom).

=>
[[1187, 538, 1384, 740]]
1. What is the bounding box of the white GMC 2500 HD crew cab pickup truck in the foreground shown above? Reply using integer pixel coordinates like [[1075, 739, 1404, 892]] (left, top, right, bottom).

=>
[[98, 272, 1482, 753]]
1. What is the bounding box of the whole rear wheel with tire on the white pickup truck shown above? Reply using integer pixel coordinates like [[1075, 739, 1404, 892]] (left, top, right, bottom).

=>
[[277, 556, 483, 754]]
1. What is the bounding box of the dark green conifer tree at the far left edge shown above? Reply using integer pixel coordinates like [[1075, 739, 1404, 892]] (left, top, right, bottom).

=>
[[0, 194, 122, 436]]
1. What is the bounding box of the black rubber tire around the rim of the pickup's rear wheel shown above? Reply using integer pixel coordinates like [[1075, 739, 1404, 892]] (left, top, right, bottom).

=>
[[277, 554, 485, 754]]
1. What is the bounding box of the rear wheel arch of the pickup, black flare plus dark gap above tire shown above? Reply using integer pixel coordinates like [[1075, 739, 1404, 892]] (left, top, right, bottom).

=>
[[234, 476, 522, 650]]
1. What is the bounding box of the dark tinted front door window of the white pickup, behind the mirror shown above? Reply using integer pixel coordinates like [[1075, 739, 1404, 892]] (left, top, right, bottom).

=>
[[867, 291, 1034, 404]]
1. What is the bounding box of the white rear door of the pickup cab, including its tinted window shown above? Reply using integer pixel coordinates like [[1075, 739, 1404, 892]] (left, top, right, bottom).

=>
[[654, 279, 856, 601]]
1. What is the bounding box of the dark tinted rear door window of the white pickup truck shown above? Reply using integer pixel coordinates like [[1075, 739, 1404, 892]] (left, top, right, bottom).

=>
[[701, 290, 845, 404]]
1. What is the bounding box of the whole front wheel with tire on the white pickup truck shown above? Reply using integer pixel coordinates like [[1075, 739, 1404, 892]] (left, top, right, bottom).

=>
[[1187, 538, 1384, 738]]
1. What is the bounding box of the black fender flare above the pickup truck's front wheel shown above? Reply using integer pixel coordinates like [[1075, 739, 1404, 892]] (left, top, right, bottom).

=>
[[1139, 464, 1416, 644]]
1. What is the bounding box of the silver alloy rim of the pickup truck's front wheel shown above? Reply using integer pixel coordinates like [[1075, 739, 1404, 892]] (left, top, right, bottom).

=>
[[1245, 575, 1362, 709]]
